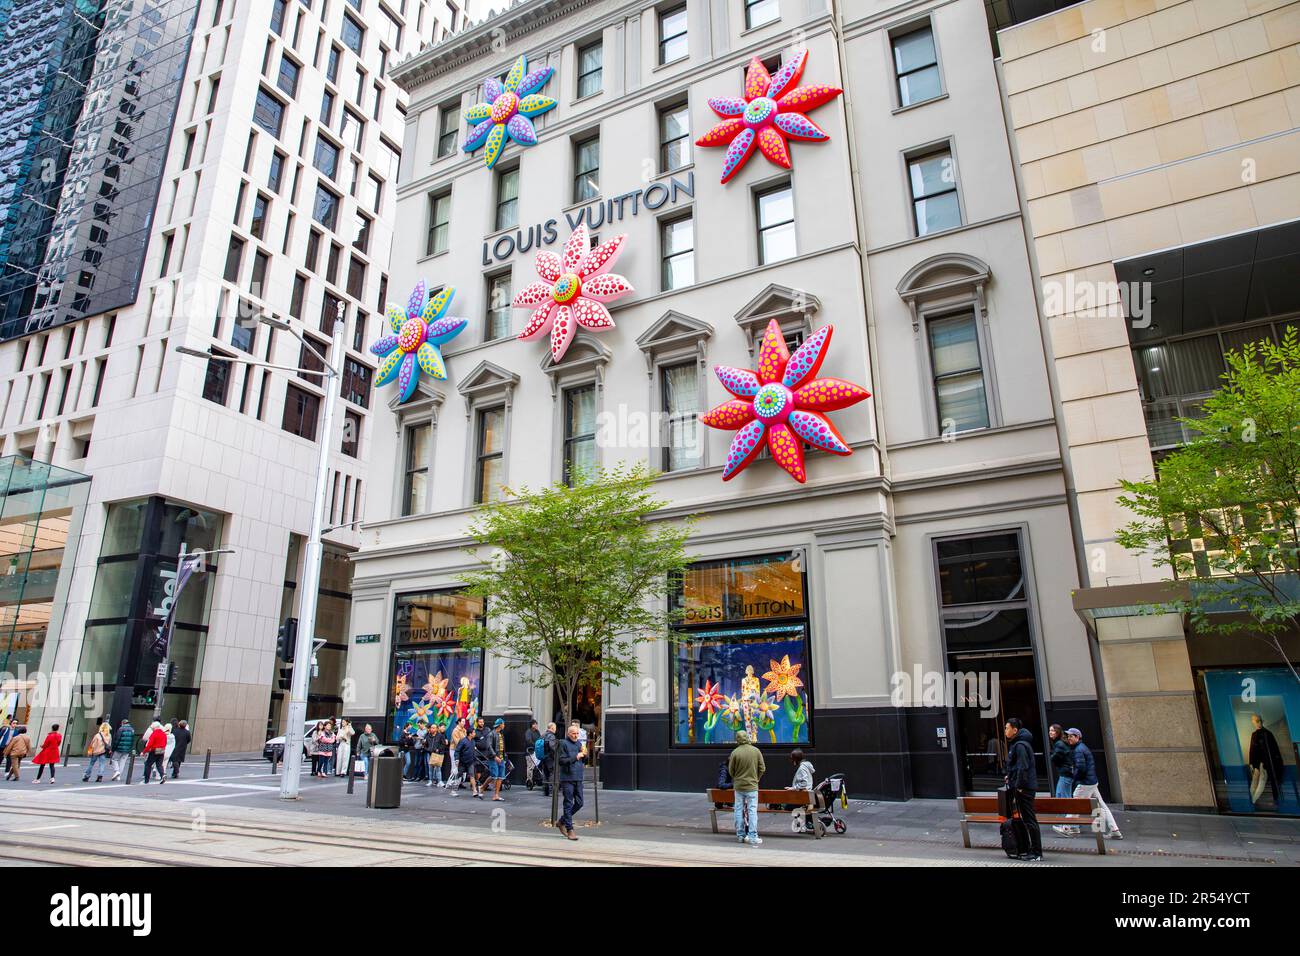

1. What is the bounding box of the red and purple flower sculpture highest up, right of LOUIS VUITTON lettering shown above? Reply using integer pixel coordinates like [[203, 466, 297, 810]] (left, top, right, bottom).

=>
[[696, 49, 844, 182]]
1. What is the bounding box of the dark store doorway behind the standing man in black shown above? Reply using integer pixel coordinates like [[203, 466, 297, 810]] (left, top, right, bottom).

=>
[[949, 650, 1047, 793]]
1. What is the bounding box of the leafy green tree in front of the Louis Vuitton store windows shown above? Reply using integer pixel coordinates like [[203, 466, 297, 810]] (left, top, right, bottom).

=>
[[460, 466, 696, 770]]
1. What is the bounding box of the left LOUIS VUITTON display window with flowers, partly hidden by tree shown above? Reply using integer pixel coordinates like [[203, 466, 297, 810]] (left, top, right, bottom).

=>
[[387, 591, 484, 741]]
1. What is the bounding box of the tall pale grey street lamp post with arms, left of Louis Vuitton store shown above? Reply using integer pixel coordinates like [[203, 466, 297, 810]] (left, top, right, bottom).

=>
[[177, 302, 346, 800]]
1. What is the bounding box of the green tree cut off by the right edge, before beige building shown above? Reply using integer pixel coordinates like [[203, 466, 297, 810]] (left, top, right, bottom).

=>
[[1117, 326, 1300, 680]]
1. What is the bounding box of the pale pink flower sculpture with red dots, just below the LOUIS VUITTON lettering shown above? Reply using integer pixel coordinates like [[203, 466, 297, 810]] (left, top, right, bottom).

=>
[[514, 224, 632, 362]]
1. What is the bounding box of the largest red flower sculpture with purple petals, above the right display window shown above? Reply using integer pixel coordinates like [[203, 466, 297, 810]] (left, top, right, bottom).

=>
[[701, 319, 871, 481]]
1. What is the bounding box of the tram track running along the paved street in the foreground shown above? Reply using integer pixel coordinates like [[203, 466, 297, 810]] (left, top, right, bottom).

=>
[[0, 803, 744, 866]]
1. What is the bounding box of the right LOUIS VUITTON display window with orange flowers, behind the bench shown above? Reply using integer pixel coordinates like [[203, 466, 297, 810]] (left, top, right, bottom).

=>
[[670, 553, 813, 747]]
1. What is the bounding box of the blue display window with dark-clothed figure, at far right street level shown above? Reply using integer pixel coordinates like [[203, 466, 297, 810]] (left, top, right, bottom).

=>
[[1197, 666, 1300, 816]]
